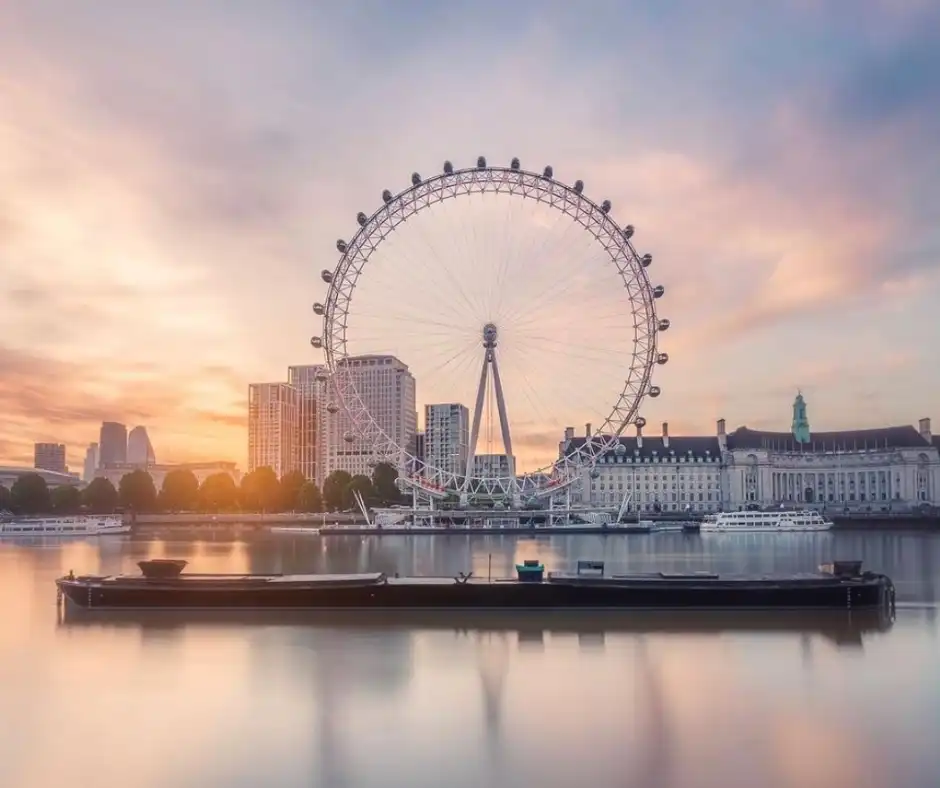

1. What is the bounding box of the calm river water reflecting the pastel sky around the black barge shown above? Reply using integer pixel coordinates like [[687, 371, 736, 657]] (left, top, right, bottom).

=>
[[0, 534, 940, 788]]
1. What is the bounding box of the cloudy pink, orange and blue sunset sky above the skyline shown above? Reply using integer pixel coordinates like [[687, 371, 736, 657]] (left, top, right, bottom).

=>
[[0, 0, 940, 474]]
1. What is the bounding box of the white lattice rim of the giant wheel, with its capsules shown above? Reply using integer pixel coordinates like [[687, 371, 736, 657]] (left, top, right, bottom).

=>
[[320, 157, 669, 497]]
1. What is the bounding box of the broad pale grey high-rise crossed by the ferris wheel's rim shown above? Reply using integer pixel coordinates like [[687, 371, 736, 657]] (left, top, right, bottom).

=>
[[320, 356, 418, 478]]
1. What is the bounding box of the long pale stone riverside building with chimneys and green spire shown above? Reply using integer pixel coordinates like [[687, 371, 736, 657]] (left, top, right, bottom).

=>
[[560, 395, 940, 513]]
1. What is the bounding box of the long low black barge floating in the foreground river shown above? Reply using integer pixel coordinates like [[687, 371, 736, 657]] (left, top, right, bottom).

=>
[[56, 560, 894, 610]]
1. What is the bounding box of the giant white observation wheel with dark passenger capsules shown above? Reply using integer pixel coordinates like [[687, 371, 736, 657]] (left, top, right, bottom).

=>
[[310, 156, 669, 502]]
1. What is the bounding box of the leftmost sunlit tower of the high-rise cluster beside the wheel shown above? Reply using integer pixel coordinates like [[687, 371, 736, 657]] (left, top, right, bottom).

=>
[[248, 383, 300, 477]]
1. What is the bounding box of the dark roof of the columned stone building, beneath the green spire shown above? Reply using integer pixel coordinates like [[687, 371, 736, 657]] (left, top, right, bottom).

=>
[[728, 425, 936, 452]]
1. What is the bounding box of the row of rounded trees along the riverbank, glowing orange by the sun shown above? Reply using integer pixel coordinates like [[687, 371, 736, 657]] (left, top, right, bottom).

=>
[[0, 462, 402, 515]]
